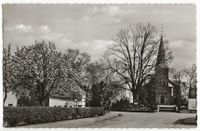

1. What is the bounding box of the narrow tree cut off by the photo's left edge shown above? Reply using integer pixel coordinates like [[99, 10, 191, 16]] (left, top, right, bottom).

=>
[[3, 44, 13, 105]]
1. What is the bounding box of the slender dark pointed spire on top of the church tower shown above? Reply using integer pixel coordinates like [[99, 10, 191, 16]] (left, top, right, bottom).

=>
[[156, 31, 166, 65]]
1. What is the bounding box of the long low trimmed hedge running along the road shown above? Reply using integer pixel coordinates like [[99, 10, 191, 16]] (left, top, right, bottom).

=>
[[3, 107, 104, 126]]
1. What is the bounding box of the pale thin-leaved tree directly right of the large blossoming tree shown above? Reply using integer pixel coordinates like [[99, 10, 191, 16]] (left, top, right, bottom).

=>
[[62, 49, 91, 106]]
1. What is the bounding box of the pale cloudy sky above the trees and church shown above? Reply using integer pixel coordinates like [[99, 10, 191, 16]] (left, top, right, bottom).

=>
[[3, 4, 196, 70]]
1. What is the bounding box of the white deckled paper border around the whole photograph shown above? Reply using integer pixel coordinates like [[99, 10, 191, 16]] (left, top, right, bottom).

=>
[[0, 0, 200, 131]]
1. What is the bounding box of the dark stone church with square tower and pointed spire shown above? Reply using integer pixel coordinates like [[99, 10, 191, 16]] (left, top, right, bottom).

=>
[[144, 35, 180, 106]]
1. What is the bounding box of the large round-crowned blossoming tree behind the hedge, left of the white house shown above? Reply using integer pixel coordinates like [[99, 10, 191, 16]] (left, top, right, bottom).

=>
[[13, 41, 64, 106]]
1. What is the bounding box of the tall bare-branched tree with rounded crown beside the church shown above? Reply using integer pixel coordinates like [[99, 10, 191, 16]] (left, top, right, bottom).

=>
[[105, 24, 172, 101]]
